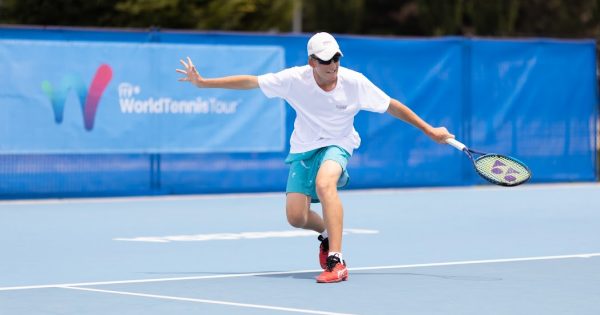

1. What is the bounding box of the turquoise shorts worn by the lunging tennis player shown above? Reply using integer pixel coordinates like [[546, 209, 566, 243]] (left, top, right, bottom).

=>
[[285, 146, 350, 203]]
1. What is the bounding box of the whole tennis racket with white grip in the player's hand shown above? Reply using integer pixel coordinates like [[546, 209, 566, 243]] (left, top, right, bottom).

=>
[[446, 139, 531, 186]]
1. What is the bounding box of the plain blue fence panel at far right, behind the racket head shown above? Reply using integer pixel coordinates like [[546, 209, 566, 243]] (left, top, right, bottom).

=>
[[468, 39, 598, 181]]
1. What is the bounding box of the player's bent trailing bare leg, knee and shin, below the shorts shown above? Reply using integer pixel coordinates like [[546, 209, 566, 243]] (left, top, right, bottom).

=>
[[286, 193, 325, 233]]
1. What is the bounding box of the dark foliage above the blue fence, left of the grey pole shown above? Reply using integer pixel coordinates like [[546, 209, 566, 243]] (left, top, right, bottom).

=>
[[0, 0, 293, 32]]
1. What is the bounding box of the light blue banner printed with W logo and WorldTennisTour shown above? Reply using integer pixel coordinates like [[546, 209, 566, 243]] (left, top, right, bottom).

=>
[[0, 40, 286, 154]]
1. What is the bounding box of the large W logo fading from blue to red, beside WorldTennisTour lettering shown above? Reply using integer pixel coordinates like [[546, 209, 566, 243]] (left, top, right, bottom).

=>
[[42, 64, 112, 131]]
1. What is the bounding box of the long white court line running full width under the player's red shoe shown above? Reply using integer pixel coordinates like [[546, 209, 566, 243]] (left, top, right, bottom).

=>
[[0, 253, 600, 291]]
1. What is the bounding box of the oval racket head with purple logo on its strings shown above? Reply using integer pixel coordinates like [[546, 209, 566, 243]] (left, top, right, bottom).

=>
[[475, 154, 531, 186]]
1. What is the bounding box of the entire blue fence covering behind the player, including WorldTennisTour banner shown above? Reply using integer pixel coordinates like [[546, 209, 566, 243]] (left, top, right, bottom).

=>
[[0, 26, 599, 199]]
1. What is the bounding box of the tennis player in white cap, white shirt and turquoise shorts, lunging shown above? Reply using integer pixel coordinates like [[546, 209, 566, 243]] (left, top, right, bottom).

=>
[[176, 33, 454, 283]]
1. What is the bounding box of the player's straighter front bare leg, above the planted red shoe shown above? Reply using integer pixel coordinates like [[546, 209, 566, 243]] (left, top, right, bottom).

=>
[[316, 160, 344, 252]]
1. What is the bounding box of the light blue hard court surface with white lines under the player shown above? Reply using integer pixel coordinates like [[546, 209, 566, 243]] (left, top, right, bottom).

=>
[[0, 184, 600, 315]]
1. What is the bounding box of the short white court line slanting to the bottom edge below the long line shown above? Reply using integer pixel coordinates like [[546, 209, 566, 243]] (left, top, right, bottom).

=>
[[60, 286, 351, 315]]
